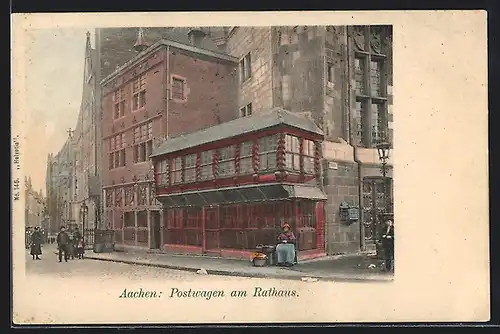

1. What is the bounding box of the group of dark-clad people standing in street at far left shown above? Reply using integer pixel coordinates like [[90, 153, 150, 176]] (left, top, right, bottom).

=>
[[30, 226, 85, 262]]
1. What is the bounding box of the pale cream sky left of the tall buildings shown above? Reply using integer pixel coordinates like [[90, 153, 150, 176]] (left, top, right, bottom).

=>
[[23, 27, 94, 194]]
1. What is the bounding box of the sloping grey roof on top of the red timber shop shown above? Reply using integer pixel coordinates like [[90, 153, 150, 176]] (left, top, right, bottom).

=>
[[150, 108, 323, 157]]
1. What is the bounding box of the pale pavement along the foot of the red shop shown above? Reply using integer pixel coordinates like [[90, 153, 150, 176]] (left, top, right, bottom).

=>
[[79, 251, 393, 282]]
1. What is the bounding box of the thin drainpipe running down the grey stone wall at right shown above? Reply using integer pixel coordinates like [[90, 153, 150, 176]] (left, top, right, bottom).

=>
[[344, 26, 366, 251]]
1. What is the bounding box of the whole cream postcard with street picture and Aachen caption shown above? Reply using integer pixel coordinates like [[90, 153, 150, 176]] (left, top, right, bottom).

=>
[[11, 11, 490, 325]]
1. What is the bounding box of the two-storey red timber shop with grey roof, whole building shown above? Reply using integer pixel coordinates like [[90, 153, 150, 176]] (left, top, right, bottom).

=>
[[152, 109, 326, 259]]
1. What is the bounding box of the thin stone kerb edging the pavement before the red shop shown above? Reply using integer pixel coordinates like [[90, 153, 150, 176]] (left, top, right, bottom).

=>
[[85, 256, 393, 283]]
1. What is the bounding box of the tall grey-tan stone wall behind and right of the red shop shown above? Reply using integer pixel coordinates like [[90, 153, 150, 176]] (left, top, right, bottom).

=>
[[221, 26, 393, 254]]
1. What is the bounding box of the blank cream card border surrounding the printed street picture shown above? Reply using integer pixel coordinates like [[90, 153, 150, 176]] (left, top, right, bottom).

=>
[[12, 11, 489, 324]]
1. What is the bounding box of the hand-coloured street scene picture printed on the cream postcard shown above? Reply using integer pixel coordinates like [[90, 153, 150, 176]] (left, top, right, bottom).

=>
[[24, 25, 397, 282]]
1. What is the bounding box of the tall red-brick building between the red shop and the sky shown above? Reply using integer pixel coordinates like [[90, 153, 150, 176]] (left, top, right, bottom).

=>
[[98, 29, 238, 248]]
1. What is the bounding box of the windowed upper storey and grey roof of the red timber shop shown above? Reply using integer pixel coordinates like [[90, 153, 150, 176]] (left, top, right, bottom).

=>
[[151, 108, 324, 206]]
